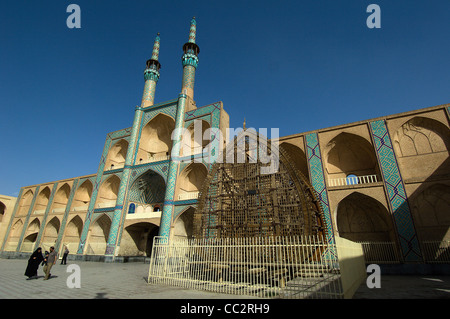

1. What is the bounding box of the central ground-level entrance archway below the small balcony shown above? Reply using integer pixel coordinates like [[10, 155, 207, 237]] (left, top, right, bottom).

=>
[[119, 222, 159, 257]]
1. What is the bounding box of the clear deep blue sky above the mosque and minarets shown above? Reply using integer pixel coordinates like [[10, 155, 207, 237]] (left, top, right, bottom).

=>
[[0, 0, 450, 196]]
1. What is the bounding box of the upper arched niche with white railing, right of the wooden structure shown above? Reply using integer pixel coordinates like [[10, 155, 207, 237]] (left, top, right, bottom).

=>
[[325, 132, 379, 179]]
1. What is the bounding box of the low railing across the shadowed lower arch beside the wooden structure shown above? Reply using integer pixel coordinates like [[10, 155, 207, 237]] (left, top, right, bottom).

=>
[[359, 242, 400, 264]]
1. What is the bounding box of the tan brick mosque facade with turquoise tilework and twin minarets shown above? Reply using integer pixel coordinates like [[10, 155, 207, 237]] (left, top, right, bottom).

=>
[[0, 19, 450, 263]]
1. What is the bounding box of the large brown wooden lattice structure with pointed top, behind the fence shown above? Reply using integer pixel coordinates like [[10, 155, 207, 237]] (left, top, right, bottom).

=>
[[194, 130, 326, 238]]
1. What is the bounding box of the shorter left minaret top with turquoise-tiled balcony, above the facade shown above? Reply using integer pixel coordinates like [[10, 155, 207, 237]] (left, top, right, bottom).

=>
[[141, 33, 161, 107]]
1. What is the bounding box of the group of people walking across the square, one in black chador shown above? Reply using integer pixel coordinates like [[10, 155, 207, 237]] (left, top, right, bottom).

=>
[[25, 246, 69, 280]]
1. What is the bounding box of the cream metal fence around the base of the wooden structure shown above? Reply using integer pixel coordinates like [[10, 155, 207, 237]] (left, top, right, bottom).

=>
[[148, 237, 366, 298]]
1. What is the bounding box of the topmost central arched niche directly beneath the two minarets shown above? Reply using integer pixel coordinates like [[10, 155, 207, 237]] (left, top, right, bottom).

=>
[[136, 113, 175, 164]]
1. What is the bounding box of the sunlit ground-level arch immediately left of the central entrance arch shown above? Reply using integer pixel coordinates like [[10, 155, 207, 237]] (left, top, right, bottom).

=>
[[86, 214, 111, 255]]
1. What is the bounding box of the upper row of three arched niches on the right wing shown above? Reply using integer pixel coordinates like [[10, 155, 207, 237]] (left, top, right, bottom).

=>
[[281, 117, 450, 185]]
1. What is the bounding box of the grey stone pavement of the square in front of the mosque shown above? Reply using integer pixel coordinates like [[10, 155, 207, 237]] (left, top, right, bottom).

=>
[[0, 258, 450, 301]]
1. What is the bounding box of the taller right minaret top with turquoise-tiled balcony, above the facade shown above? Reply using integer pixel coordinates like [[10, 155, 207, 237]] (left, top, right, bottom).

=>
[[181, 17, 200, 100]]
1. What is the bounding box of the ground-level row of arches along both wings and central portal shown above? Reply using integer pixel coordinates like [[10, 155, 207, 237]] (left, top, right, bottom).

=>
[[3, 184, 450, 255]]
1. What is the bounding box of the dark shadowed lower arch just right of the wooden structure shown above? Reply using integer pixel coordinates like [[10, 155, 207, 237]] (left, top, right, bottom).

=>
[[336, 192, 396, 242]]
